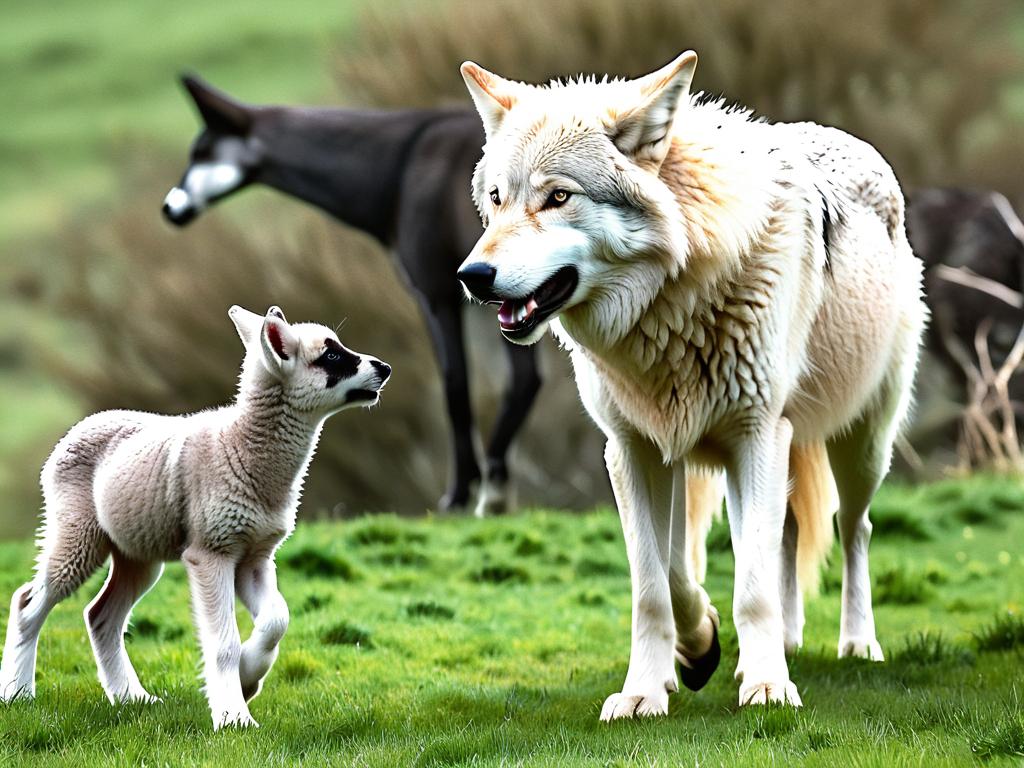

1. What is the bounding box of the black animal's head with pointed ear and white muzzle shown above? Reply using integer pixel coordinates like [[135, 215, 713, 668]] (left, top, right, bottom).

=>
[[164, 75, 262, 226]]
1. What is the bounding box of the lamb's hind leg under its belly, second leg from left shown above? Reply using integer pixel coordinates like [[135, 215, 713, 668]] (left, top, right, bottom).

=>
[[85, 550, 164, 702]]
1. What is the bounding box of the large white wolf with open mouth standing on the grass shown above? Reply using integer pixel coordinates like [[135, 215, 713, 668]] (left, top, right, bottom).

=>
[[459, 51, 927, 720]]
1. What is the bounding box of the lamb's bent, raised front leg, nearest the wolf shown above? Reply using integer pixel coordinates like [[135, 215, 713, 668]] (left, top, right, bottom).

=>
[[234, 557, 288, 701]]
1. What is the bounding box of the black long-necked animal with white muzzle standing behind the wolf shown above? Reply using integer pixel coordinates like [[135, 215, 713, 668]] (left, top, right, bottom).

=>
[[164, 77, 541, 514]]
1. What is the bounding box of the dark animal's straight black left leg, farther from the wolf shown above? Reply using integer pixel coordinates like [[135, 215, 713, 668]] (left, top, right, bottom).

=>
[[426, 302, 480, 510]]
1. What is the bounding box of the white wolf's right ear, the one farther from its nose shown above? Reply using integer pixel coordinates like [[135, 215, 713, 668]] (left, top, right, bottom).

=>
[[607, 50, 697, 169]]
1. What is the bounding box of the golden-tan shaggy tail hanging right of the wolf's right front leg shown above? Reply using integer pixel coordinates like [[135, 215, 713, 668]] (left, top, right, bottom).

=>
[[790, 441, 839, 594]]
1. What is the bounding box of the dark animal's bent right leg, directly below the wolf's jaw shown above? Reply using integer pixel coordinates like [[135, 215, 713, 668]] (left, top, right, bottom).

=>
[[476, 342, 541, 517]]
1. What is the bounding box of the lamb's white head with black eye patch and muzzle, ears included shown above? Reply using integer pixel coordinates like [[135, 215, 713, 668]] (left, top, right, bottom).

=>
[[227, 306, 391, 416]]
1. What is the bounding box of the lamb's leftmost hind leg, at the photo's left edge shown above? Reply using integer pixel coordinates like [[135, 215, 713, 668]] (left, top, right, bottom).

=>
[[0, 493, 111, 701]]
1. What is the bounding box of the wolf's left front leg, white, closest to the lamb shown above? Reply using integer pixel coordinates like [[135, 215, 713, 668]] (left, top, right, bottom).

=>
[[601, 436, 678, 721]]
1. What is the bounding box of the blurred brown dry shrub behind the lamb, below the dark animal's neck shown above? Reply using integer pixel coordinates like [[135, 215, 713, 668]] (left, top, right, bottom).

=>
[[47, 161, 606, 515]]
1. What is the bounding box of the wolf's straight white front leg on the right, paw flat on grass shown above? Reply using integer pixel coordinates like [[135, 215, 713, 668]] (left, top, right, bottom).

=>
[[728, 419, 801, 707]]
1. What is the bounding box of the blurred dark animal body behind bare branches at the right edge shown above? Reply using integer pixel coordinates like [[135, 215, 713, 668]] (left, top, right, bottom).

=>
[[906, 188, 1024, 405]]
